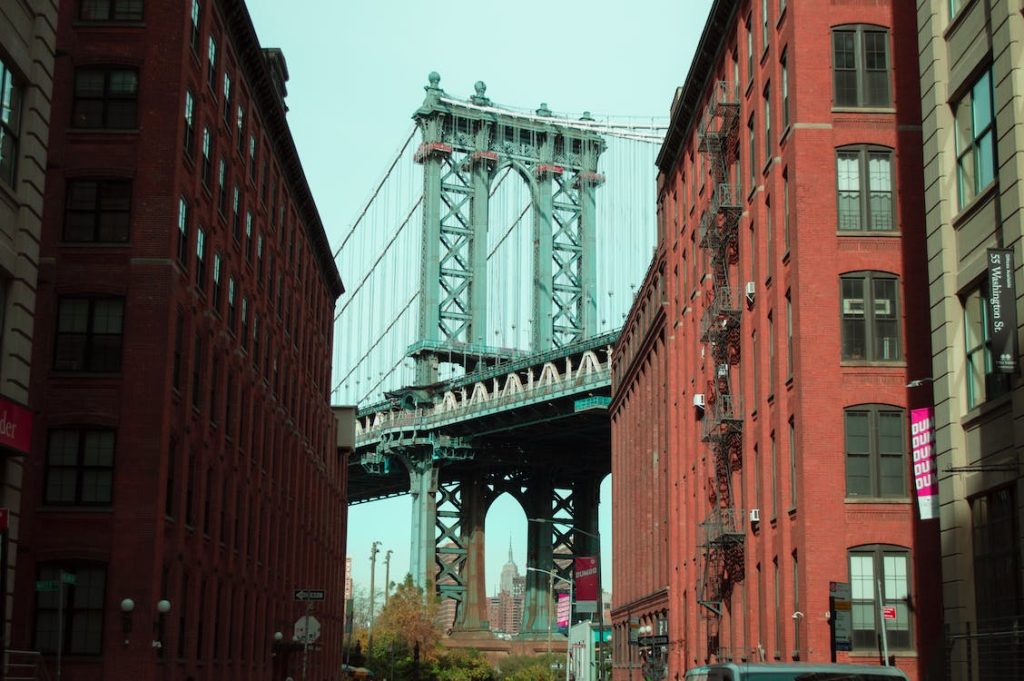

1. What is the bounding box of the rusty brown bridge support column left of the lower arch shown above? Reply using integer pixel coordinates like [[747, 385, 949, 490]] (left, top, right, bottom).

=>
[[456, 473, 488, 632]]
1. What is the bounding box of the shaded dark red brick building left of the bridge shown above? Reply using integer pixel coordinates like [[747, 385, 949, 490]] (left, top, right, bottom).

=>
[[12, 0, 346, 681]]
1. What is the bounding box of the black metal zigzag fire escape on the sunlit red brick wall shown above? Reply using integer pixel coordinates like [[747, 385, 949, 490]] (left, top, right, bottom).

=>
[[697, 81, 744, 659]]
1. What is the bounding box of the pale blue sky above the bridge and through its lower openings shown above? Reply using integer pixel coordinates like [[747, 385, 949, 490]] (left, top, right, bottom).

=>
[[241, 0, 711, 592]]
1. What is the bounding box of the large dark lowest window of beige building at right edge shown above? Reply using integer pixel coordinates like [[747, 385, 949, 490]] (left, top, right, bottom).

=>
[[971, 487, 1024, 622]]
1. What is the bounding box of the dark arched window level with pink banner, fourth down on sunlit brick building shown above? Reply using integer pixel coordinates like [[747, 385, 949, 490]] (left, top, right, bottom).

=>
[[844, 405, 906, 498]]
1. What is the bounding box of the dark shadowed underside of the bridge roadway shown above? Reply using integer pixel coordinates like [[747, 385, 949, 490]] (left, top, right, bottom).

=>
[[348, 388, 611, 504]]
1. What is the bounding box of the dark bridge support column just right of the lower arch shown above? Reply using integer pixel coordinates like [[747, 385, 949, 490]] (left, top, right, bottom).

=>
[[519, 482, 555, 638]]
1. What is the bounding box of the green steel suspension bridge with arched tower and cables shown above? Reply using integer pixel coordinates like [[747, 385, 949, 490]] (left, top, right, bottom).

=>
[[332, 73, 665, 637]]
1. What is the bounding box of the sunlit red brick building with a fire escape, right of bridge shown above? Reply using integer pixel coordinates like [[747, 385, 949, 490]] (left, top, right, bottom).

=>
[[611, 0, 942, 679]]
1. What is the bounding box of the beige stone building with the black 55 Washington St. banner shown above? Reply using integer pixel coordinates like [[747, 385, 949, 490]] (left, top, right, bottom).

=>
[[910, 0, 1024, 680]]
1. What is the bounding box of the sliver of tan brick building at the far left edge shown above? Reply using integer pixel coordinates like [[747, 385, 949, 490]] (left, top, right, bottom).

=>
[[0, 0, 57, 659]]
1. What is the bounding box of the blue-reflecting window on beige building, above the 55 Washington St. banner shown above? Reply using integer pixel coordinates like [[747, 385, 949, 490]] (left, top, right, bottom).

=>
[[953, 71, 995, 208]]
